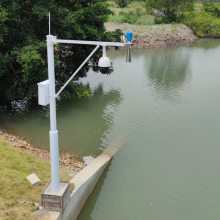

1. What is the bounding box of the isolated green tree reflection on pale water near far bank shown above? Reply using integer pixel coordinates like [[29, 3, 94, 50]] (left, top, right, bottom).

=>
[[148, 48, 190, 99]]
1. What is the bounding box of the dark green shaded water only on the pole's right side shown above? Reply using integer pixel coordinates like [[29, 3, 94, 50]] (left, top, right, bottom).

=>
[[58, 84, 121, 155]]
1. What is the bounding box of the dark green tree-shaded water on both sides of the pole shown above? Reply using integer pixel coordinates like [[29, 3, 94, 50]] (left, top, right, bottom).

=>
[[0, 85, 121, 155]]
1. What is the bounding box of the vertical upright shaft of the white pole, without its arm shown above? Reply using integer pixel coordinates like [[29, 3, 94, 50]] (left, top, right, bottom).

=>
[[47, 35, 60, 193]]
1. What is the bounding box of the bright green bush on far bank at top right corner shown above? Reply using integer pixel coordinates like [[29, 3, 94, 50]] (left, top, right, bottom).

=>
[[179, 3, 220, 38]]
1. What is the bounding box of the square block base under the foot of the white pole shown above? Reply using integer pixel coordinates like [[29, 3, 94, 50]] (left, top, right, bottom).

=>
[[41, 182, 71, 213]]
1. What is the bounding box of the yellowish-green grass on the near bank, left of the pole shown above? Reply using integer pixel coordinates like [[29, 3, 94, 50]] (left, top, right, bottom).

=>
[[0, 140, 68, 220]]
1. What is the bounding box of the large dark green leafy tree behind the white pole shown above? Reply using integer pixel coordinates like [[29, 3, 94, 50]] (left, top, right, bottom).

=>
[[0, 0, 118, 106]]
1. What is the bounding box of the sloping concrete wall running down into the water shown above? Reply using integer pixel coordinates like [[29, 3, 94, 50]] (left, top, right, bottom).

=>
[[40, 146, 119, 220]]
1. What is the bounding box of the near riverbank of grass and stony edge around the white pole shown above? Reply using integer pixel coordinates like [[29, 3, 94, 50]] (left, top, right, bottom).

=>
[[0, 130, 84, 220]]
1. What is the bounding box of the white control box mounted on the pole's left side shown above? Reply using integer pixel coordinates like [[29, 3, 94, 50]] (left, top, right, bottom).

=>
[[37, 80, 50, 106]]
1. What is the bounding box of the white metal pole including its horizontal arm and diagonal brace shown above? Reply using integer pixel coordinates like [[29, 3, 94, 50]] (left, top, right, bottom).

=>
[[43, 33, 129, 193]]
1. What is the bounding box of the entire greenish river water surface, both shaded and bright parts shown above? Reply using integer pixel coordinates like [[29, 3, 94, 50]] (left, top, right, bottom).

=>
[[0, 40, 220, 220]]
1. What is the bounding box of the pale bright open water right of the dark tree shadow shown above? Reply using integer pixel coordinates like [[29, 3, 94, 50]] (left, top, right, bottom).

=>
[[79, 41, 220, 220]]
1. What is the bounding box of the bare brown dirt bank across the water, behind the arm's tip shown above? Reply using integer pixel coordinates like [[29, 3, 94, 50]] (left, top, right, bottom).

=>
[[105, 23, 197, 48]]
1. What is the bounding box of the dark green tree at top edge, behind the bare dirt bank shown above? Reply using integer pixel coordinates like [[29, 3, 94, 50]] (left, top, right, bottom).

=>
[[146, 0, 194, 23]]
